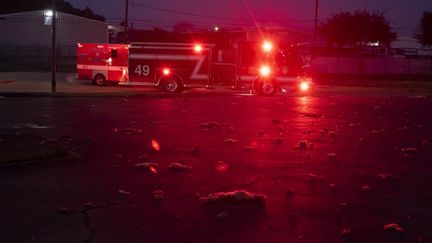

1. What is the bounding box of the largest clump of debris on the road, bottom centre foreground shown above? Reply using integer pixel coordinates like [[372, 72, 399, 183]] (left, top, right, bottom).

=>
[[200, 190, 266, 204]]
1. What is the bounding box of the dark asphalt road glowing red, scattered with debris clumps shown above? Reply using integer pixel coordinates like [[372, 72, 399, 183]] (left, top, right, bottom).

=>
[[0, 92, 432, 243]]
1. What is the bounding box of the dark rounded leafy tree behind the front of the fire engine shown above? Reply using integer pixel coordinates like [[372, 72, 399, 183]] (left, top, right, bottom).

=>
[[320, 10, 396, 46]]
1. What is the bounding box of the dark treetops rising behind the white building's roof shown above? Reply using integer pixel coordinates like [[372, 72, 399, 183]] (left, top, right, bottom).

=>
[[0, 0, 105, 21]]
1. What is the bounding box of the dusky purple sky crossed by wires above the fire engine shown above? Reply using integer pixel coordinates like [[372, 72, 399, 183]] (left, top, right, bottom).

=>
[[69, 0, 432, 36]]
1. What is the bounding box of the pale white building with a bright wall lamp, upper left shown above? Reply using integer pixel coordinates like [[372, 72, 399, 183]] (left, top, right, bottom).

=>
[[0, 10, 108, 56]]
